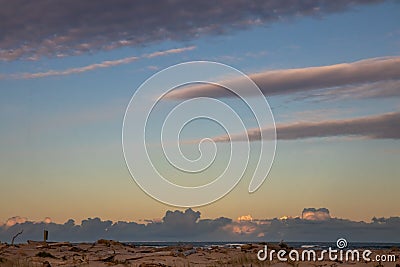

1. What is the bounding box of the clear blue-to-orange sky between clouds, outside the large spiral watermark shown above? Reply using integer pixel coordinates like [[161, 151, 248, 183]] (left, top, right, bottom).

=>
[[0, 1, 400, 228]]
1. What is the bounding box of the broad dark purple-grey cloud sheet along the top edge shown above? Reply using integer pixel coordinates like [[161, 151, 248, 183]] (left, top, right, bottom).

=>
[[0, 0, 381, 60]]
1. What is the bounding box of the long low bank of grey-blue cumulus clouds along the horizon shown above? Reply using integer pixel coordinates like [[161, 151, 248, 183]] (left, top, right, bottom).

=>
[[0, 208, 400, 245]]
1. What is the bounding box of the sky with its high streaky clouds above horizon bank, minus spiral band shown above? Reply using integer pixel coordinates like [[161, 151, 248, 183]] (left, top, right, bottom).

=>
[[0, 0, 400, 243]]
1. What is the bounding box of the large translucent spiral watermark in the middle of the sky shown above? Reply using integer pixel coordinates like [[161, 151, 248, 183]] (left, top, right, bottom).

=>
[[122, 61, 276, 207]]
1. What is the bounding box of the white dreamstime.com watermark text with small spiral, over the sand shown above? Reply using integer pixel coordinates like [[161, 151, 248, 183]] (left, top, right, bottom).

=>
[[257, 238, 396, 262]]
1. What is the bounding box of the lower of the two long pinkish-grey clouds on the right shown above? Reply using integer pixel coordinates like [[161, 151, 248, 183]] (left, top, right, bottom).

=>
[[213, 112, 400, 142]]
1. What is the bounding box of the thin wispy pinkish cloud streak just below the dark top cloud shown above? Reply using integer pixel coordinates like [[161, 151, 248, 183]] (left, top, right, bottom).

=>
[[5, 46, 196, 79]]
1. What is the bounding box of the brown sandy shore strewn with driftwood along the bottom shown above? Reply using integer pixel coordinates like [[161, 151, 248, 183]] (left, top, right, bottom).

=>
[[0, 240, 400, 267]]
